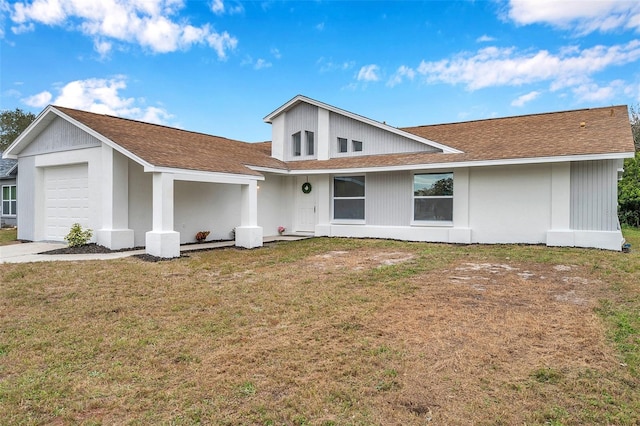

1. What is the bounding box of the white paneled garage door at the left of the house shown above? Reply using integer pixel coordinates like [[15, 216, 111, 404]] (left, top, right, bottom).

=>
[[44, 163, 89, 241]]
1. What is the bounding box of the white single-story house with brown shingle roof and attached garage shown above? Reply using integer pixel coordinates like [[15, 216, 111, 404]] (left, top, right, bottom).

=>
[[5, 96, 634, 257]]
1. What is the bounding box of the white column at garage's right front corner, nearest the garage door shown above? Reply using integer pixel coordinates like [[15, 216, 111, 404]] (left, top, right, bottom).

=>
[[96, 144, 134, 250]]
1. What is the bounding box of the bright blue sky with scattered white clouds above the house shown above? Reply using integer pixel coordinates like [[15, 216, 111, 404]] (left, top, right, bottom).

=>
[[0, 0, 640, 142]]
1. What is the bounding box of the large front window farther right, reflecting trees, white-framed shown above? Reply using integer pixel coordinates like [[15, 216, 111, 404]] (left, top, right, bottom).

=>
[[413, 173, 453, 222]]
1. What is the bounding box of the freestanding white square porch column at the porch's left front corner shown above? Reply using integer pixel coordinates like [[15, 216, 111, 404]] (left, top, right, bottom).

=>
[[145, 173, 180, 257]]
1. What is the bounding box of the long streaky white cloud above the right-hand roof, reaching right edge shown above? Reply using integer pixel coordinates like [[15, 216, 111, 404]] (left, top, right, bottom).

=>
[[417, 40, 640, 90]]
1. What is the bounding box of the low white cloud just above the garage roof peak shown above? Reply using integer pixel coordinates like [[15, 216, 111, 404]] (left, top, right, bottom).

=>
[[22, 76, 173, 124]]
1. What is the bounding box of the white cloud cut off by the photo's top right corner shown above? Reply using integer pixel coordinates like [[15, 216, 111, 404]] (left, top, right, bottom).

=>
[[508, 0, 640, 34]]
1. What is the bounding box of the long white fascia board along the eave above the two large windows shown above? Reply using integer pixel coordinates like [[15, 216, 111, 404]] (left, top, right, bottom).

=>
[[276, 152, 634, 175]]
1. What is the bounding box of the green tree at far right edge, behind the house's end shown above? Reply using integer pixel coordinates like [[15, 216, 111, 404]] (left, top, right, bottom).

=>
[[618, 107, 640, 227]]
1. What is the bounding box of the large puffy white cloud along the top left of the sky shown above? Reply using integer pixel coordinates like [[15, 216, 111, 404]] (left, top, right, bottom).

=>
[[11, 0, 238, 59]]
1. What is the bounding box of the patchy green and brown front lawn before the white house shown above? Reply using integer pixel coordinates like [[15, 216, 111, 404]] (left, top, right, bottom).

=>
[[0, 235, 640, 425]]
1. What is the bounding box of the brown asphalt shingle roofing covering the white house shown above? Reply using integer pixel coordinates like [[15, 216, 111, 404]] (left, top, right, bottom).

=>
[[56, 106, 634, 175]]
